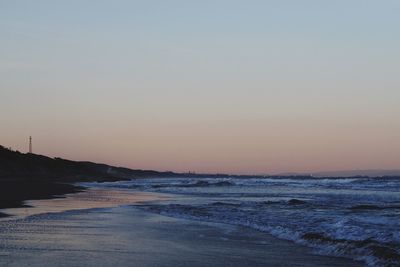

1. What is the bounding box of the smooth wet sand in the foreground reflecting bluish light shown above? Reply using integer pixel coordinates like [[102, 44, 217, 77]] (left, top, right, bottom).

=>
[[0, 190, 360, 267]]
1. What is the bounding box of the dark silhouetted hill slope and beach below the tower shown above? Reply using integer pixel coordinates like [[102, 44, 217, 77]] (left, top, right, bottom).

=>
[[0, 146, 173, 213]]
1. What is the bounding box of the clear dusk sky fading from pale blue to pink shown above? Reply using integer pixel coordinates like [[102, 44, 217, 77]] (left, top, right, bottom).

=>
[[0, 0, 400, 174]]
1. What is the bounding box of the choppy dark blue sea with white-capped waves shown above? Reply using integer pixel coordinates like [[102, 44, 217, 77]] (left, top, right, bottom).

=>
[[84, 178, 400, 266]]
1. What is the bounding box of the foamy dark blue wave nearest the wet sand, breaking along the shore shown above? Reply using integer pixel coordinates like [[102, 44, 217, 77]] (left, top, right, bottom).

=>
[[140, 201, 400, 266]]
